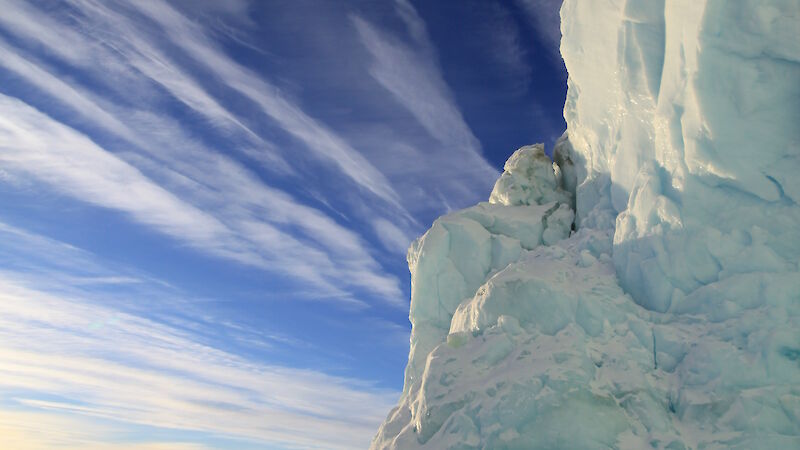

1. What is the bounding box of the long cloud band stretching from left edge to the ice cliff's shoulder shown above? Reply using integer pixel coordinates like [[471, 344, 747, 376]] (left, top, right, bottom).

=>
[[0, 95, 403, 305]]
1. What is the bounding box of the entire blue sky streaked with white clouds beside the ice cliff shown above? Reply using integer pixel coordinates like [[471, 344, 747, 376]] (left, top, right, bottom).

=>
[[0, 0, 566, 449]]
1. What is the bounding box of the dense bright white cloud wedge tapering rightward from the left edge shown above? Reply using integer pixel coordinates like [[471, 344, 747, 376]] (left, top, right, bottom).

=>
[[0, 95, 233, 246]]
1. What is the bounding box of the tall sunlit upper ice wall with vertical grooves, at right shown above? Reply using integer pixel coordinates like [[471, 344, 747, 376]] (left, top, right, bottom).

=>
[[561, 0, 800, 311]]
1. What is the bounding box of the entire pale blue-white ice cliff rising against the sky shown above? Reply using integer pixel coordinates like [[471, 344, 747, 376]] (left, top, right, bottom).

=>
[[373, 0, 800, 449]]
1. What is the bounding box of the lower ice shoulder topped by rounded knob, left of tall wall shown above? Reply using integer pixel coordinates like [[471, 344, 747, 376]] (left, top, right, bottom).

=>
[[404, 150, 573, 392]]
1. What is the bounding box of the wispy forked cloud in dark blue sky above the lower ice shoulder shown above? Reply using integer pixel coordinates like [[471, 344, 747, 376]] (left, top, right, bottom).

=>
[[350, 0, 498, 216]]
